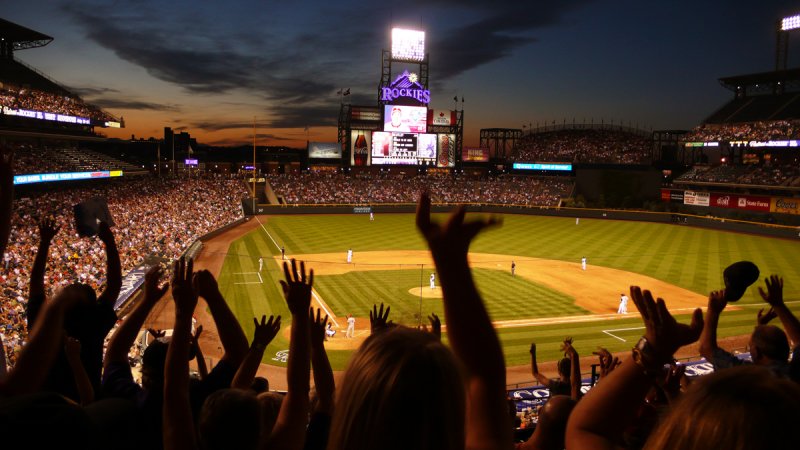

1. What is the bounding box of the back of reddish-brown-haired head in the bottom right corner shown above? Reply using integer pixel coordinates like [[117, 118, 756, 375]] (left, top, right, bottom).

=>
[[645, 366, 800, 450]]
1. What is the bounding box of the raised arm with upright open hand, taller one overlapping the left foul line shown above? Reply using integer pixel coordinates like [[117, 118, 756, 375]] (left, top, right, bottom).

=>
[[268, 259, 314, 450]]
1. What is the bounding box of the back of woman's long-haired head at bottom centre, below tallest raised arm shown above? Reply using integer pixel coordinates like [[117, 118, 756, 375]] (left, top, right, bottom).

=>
[[328, 327, 465, 449]]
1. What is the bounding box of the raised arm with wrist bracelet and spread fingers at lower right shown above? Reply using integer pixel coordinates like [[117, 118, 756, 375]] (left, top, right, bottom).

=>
[[566, 286, 703, 449]]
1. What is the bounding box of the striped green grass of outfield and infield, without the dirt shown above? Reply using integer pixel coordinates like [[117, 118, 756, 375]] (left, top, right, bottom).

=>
[[220, 214, 800, 369]]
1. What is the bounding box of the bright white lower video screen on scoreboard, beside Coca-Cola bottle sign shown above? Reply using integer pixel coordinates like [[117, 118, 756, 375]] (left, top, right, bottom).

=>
[[371, 131, 436, 165]]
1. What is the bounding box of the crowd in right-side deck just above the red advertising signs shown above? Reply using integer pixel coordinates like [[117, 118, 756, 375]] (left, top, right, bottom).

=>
[[675, 164, 800, 187]]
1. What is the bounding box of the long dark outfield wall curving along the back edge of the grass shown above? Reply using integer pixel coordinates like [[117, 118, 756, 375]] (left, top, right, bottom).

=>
[[243, 201, 800, 240]]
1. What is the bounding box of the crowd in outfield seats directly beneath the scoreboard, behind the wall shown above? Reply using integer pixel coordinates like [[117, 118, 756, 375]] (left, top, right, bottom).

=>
[[269, 172, 572, 206]]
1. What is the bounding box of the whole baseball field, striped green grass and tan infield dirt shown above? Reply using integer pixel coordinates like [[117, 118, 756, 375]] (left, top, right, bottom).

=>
[[210, 214, 800, 370]]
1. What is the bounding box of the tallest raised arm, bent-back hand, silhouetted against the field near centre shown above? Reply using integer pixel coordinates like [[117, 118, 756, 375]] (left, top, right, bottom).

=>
[[417, 193, 512, 448]]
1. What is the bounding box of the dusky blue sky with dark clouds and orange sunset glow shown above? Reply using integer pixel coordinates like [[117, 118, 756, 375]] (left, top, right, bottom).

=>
[[0, 0, 800, 146]]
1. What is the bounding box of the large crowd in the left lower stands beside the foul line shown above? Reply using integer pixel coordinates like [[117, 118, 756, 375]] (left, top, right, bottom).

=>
[[0, 177, 247, 368]]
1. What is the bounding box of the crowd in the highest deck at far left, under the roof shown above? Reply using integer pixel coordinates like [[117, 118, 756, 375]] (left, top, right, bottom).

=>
[[0, 84, 116, 121]]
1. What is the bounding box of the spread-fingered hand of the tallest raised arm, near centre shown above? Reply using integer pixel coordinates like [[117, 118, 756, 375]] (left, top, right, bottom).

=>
[[417, 192, 500, 258]]
